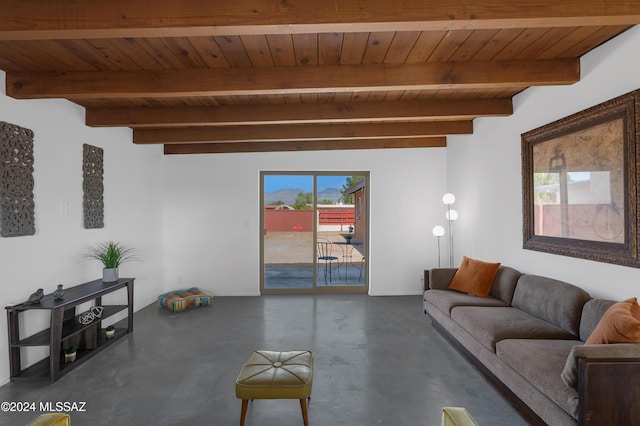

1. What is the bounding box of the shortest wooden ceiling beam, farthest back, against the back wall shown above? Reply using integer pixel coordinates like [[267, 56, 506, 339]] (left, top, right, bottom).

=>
[[164, 136, 447, 155]]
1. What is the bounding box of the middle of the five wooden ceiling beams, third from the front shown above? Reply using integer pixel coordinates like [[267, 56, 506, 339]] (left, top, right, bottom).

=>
[[85, 98, 513, 128]]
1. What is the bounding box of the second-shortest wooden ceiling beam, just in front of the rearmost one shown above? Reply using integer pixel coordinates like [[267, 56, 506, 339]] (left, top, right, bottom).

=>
[[133, 121, 473, 144]]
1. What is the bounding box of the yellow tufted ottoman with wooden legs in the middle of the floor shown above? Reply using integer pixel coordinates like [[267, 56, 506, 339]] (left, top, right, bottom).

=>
[[236, 351, 313, 426]]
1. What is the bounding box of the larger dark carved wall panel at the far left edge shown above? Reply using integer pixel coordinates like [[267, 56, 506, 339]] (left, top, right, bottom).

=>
[[0, 121, 36, 237]]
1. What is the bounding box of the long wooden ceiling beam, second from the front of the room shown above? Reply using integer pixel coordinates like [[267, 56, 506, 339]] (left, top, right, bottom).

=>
[[6, 58, 580, 99]]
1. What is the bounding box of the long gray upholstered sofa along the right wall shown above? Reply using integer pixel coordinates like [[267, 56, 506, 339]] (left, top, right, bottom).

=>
[[423, 266, 640, 425]]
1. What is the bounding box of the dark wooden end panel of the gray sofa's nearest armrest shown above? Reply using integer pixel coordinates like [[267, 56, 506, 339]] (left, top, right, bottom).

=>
[[578, 354, 640, 426]]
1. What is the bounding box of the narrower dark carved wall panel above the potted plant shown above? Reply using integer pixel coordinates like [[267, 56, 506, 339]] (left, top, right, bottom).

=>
[[82, 144, 104, 229]]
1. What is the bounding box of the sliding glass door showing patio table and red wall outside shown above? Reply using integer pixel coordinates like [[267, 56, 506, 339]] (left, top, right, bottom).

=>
[[260, 172, 368, 294]]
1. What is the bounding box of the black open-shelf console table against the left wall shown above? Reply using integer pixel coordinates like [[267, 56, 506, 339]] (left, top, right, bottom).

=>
[[5, 278, 134, 382]]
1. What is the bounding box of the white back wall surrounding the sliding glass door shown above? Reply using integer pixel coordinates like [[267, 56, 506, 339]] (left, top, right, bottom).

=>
[[164, 148, 446, 295]]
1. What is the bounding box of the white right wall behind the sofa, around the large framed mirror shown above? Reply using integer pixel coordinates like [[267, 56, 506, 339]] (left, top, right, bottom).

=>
[[447, 27, 640, 300]]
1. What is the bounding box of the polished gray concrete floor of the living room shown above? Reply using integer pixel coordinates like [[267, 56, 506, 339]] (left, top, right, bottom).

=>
[[0, 295, 526, 426]]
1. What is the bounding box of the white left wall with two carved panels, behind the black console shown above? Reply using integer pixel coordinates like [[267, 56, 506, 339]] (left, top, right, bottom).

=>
[[0, 72, 163, 383]]
